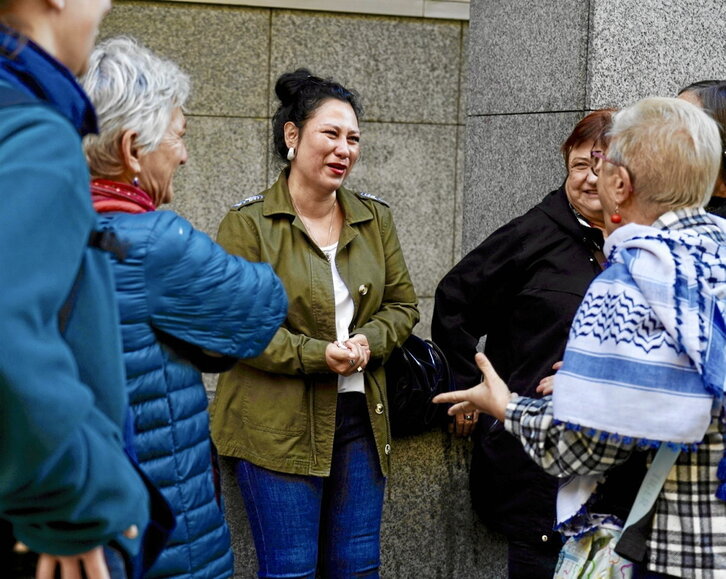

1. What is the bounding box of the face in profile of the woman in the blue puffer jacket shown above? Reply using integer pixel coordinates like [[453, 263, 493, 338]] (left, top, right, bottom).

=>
[[138, 107, 187, 207]]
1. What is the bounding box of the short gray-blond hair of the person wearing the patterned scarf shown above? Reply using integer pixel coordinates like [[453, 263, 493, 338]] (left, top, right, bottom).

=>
[[608, 97, 721, 211]]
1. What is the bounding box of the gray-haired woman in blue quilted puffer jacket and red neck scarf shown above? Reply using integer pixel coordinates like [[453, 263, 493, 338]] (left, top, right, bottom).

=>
[[79, 38, 287, 579]]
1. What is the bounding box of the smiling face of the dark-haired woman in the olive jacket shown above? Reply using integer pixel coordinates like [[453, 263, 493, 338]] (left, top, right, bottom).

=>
[[285, 99, 360, 193]]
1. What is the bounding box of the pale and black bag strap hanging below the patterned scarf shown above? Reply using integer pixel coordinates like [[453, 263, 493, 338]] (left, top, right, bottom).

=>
[[615, 444, 681, 563]]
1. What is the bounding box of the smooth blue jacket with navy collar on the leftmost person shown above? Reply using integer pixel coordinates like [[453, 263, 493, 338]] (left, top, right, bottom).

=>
[[0, 28, 149, 555]]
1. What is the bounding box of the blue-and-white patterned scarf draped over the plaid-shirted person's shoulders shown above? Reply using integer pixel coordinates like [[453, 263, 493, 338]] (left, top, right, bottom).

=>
[[553, 209, 726, 520]]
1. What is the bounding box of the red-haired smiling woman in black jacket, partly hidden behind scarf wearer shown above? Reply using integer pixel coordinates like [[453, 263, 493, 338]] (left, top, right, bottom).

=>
[[432, 110, 612, 579]]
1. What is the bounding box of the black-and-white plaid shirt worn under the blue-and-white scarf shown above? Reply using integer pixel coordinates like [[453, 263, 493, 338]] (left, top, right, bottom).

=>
[[505, 396, 726, 579]]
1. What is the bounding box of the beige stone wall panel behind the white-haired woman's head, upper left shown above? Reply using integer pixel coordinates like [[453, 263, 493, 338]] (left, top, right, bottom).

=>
[[102, 2, 270, 117]]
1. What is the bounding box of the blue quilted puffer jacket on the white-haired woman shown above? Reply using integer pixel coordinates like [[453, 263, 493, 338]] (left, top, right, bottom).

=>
[[101, 201, 287, 579]]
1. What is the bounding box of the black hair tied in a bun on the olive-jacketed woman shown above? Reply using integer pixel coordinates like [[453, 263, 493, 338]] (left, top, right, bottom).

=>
[[272, 68, 363, 161]]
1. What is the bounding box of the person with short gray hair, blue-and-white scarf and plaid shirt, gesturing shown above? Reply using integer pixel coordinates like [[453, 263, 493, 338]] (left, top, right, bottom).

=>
[[436, 98, 726, 577]]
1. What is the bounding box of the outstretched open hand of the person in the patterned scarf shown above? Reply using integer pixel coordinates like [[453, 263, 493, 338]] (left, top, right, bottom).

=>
[[434, 354, 512, 422]]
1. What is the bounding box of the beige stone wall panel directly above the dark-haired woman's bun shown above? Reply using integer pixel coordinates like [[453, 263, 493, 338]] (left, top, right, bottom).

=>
[[270, 11, 463, 123]]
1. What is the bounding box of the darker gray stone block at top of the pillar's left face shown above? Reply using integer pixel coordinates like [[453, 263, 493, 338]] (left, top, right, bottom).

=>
[[468, 0, 592, 115]]
